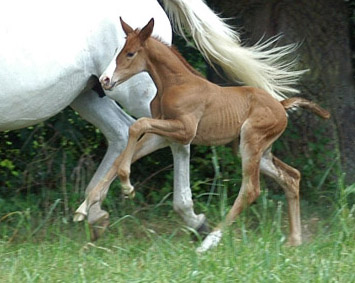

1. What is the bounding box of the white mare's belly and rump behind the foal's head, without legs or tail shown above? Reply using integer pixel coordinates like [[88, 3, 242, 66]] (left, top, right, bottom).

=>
[[0, 0, 171, 130]]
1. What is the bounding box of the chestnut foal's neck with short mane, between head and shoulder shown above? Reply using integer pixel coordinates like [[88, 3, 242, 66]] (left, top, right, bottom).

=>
[[146, 38, 200, 95]]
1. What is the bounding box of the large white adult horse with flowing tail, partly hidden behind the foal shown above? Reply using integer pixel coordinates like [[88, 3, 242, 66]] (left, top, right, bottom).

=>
[[0, 0, 302, 244]]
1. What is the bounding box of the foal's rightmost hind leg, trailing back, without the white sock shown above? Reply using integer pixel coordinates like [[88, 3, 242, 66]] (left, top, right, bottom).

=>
[[260, 150, 302, 246]]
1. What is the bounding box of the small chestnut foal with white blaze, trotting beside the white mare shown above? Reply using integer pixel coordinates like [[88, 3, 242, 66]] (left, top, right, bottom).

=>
[[101, 19, 329, 251]]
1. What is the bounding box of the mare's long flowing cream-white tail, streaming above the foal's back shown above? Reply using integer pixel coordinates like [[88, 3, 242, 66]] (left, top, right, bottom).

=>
[[162, 0, 305, 100]]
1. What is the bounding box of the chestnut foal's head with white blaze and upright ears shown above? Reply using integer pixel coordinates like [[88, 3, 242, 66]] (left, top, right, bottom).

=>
[[100, 18, 154, 90]]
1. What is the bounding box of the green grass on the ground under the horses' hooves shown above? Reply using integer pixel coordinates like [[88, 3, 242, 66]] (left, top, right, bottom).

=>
[[0, 186, 355, 283]]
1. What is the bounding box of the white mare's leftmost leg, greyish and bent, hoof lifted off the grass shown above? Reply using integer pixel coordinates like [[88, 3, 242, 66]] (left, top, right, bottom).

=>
[[71, 91, 135, 240]]
